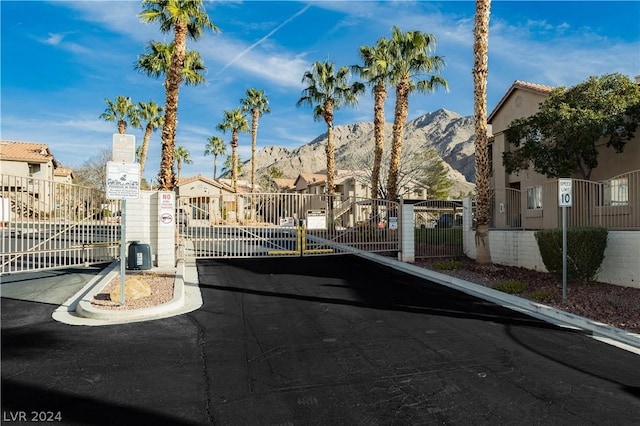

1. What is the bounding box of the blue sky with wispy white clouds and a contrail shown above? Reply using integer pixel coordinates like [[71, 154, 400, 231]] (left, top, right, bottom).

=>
[[0, 0, 640, 182]]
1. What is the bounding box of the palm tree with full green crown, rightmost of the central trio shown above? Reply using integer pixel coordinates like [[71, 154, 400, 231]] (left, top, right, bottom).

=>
[[387, 26, 448, 201]]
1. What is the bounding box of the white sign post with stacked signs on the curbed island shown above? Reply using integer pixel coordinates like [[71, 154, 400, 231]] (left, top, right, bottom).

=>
[[106, 133, 140, 306]]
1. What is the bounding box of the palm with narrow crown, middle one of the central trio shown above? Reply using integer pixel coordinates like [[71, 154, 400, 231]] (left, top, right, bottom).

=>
[[353, 37, 391, 198]]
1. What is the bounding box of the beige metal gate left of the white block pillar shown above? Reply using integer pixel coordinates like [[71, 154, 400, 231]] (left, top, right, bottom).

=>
[[0, 175, 120, 274]]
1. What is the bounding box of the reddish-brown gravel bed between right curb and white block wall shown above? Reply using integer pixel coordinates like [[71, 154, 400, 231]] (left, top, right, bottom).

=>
[[415, 258, 640, 333]]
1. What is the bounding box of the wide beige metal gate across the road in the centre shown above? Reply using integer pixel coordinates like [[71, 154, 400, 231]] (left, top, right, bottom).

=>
[[176, 193, 399, 258]]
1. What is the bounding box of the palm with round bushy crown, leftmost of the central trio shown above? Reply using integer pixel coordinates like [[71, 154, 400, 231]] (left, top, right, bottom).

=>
[[296, 61, 365, 195]]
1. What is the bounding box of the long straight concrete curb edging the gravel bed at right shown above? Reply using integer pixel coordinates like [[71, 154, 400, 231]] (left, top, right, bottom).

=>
[[359, 253, 640, 353]]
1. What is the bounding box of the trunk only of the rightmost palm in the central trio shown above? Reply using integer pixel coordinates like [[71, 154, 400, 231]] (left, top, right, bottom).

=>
[[387, 80, 409, 201]]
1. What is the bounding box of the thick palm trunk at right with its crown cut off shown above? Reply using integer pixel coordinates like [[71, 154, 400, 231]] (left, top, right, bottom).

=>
[[473, 0, 491, 265]]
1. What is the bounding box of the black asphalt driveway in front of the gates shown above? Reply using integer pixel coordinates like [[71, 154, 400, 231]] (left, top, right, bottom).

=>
[[2, 256, 640, 425]]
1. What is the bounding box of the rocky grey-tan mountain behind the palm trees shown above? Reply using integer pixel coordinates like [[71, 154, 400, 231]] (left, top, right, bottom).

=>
[[243, 109, 475, 196]]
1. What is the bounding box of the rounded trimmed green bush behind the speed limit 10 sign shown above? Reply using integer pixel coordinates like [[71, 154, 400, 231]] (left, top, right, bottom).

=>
[[535, 227, 607, 281]]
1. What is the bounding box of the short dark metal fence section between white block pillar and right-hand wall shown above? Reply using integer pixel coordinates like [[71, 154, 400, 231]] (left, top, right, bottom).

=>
[[413, 200, 464, 258]]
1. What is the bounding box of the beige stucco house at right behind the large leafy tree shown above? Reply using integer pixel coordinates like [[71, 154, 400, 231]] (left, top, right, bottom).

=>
[[487, 81, 640, 229]]
